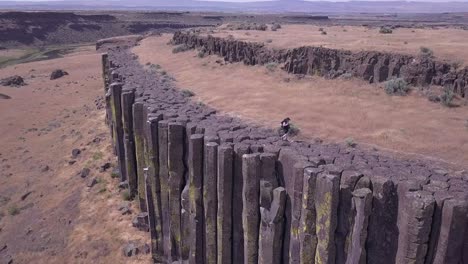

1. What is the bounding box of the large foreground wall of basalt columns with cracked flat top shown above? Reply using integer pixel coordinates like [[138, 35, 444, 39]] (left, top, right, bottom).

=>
[[103, 42, 468, 264]]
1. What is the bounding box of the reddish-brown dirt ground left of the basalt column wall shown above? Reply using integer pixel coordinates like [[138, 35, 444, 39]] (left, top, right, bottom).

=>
[[0, 47, 150, 264]]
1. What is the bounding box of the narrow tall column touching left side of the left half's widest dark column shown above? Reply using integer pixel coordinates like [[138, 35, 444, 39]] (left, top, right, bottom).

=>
[[158, 120, 171, 261]]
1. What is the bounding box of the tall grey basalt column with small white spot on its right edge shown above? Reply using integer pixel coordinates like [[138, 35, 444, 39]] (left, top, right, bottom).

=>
[[133, 102, 146, 212]]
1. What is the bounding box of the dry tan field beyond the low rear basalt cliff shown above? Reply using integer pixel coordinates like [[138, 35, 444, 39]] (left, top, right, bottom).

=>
[[211, 25, 468, 64]]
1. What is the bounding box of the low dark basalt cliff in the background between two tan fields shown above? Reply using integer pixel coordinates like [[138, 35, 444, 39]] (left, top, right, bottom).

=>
[[173, 31, 468, 98]]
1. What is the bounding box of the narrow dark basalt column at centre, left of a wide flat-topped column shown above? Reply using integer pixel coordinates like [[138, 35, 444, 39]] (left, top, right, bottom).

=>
[[232, 144, 250, 263]]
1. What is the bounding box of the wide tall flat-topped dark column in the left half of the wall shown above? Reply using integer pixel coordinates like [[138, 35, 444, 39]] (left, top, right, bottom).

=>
[[168, 123, 185, 261]]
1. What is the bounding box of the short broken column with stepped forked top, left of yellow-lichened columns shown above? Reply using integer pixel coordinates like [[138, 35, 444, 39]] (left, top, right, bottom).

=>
[[258, 187, 286, 264]]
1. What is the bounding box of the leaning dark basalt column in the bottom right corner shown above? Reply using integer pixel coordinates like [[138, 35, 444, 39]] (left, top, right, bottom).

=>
[[433, 199, 468, 263]]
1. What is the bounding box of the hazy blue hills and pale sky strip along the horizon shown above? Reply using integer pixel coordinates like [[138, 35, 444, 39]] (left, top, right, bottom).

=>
[[0, 0, 468, 13]]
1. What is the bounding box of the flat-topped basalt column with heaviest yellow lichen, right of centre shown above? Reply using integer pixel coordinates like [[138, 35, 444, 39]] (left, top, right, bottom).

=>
[[315, 174, 340, 264]]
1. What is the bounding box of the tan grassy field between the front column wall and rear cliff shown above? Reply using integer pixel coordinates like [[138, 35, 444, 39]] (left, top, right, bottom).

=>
[[133, 32, 468, 166]]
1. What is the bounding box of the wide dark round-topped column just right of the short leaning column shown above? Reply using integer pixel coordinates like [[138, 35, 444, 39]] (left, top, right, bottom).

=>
[[367, 176, 400, 264]]
